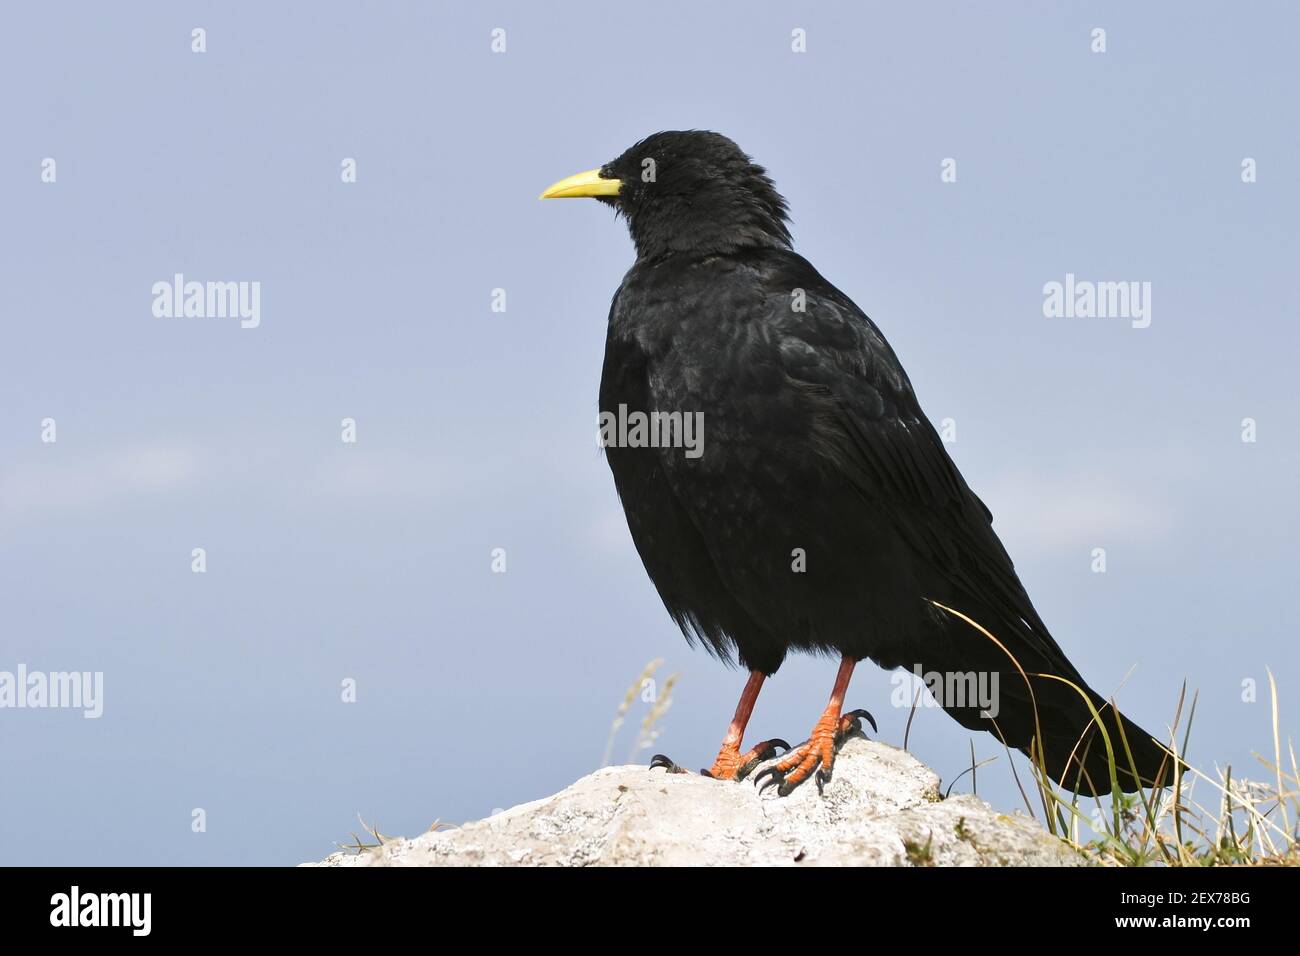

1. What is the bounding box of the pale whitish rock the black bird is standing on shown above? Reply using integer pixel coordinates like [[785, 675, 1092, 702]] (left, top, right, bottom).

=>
[[304, 737, 1084, 866]]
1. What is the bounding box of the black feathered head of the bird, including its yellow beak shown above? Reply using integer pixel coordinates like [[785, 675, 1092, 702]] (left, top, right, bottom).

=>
[[541, 130, 790, 259]]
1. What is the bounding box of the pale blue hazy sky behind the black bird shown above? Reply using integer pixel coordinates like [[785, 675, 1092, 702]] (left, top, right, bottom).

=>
[[0, 3, 1300, 864]]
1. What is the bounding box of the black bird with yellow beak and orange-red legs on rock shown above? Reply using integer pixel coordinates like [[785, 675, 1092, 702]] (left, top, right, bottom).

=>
[[542, 130, 1171, 796]]
